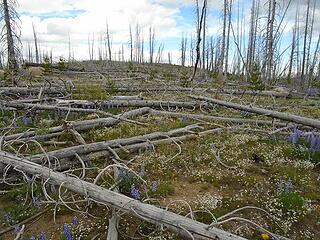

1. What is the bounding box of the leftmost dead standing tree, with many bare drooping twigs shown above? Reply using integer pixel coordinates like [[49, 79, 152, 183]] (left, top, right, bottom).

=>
[[0, 0, 20, 71]]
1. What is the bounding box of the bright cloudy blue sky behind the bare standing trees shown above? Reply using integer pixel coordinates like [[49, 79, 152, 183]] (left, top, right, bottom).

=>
[[17, 0, 320, 63]]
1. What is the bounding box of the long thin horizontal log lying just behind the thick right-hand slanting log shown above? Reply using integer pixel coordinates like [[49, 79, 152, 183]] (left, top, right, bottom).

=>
[[106, 87, 290, 97]]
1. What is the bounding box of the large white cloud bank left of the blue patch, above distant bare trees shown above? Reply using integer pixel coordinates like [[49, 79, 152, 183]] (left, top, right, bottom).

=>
[[19, 0, 180, 61]]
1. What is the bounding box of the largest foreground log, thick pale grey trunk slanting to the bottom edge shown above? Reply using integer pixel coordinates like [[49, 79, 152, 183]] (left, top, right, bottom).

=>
[[0, 151, 245, 240]]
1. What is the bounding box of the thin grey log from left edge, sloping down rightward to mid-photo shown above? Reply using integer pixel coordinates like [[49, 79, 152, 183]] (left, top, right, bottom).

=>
[[0, 101, 147, 126]]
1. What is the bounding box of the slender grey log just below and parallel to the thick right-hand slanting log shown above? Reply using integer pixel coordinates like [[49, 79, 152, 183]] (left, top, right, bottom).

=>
[[150, 109, 288, 127]]
